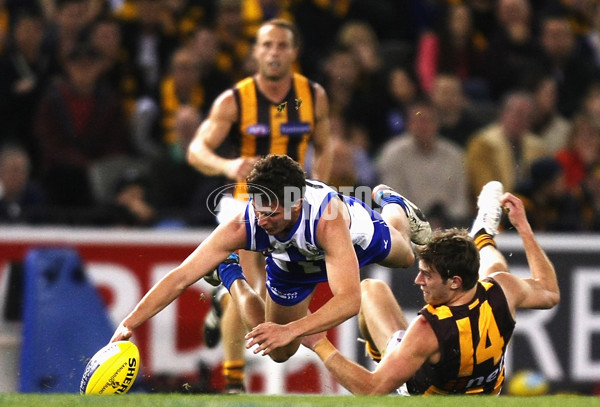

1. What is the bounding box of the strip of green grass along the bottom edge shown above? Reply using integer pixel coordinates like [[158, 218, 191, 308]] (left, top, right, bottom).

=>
[[0, 393, 600, 407]]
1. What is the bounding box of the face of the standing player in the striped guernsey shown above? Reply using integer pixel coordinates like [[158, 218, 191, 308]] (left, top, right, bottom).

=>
[[254, 25, 298, 81]]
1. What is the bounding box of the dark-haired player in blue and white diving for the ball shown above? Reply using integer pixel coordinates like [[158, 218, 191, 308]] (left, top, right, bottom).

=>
[[111, 154, 431, 362]]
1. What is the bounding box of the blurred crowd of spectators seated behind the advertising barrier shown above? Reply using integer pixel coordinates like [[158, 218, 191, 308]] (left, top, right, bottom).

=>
[[0, 0, 600, 232]]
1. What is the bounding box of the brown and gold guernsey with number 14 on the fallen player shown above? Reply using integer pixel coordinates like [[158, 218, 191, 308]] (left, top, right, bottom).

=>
[[406, 278, 515, 394]]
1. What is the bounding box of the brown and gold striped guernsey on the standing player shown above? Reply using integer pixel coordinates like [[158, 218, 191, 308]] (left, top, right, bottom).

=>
[[232, 73, 316, 167]]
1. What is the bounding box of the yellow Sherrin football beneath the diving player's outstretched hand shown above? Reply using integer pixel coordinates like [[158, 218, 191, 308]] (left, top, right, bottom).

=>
[[79, 341, 140, 394]]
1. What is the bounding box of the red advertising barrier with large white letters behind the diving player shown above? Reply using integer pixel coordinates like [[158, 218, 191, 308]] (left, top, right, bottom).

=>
[[0, 227, 344, 393]]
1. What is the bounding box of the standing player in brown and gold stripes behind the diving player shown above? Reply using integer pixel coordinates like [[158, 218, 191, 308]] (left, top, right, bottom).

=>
[[188, 19, 333, 393]]
